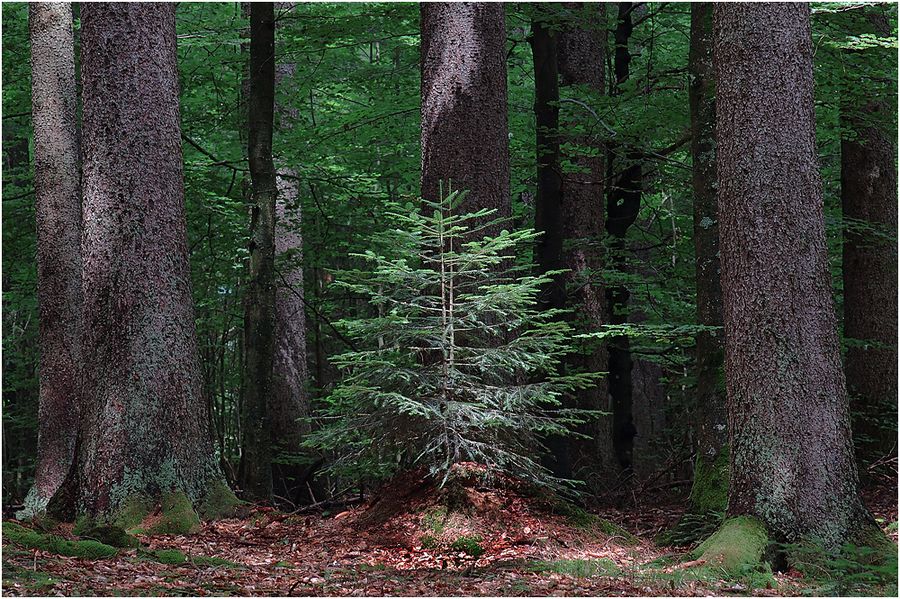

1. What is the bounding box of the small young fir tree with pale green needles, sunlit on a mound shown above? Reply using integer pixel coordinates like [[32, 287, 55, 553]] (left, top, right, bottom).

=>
[[312, 192, 595, 486]]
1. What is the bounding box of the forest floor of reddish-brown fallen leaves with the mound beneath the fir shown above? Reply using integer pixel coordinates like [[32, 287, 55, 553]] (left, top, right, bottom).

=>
[[3, 468, 897, 596]]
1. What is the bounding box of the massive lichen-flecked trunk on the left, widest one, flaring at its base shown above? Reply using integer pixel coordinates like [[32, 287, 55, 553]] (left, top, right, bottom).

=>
[[78, 3, 222, 517]]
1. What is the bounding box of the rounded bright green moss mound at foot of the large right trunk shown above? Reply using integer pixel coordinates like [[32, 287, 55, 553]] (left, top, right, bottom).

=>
[[692, 516, 769, 575]]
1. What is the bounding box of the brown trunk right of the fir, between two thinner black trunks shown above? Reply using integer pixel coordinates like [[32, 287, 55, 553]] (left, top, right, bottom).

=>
[[558, 2, 616, 488]]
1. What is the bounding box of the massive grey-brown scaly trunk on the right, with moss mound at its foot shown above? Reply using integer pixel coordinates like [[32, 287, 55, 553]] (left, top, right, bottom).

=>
[[714, 3, 871, 547]]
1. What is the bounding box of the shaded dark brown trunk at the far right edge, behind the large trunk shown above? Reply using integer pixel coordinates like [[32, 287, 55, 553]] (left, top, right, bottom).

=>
[[841, 103, 897, 461]]
